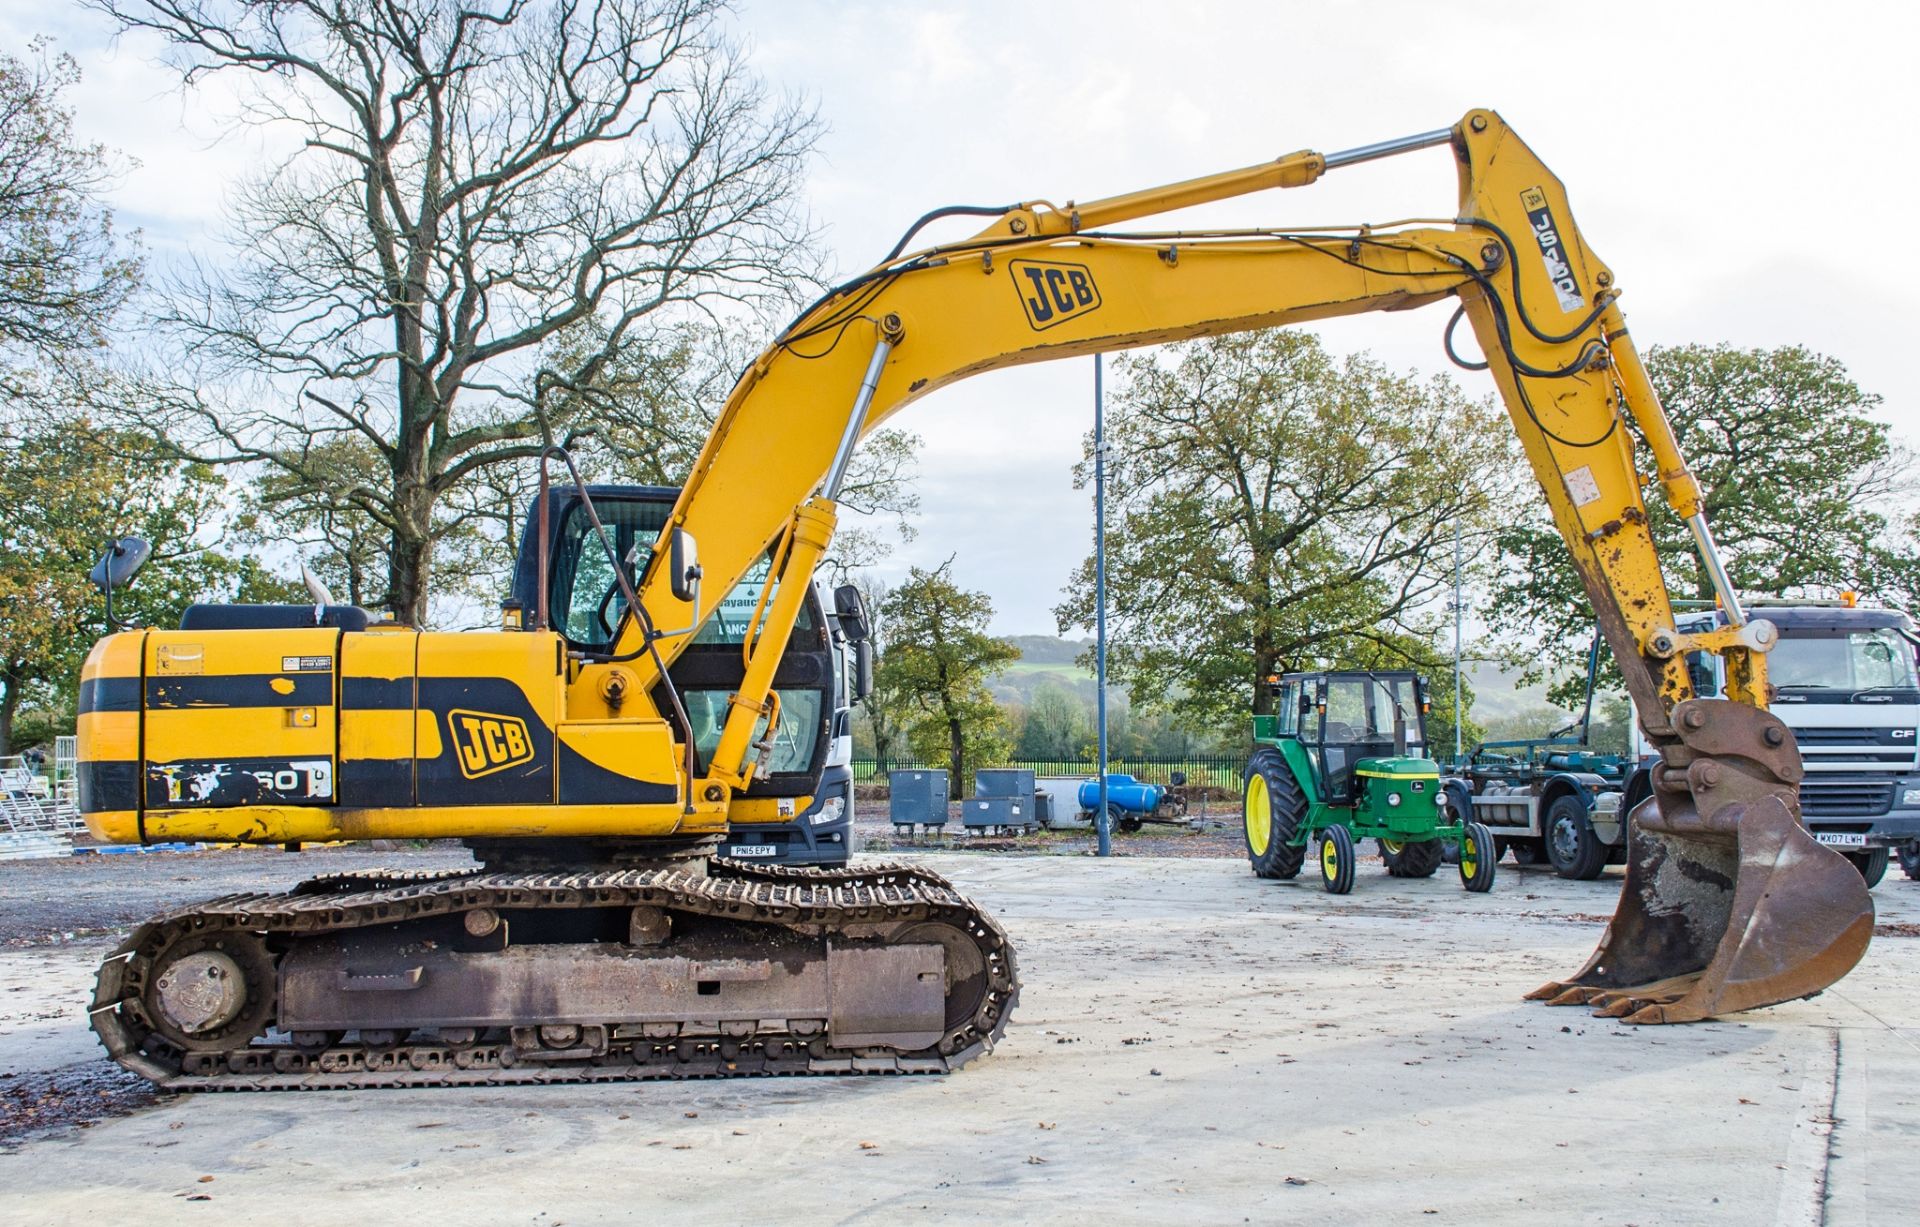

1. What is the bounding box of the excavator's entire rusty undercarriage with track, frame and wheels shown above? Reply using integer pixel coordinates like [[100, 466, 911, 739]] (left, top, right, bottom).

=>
[[92, 860, 1020, 1091]]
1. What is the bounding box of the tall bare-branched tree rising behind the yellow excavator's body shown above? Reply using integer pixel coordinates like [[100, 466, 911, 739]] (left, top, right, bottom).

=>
[[99, 0, 814, 622]]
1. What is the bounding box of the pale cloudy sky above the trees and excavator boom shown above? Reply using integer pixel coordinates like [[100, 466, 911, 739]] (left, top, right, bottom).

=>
[[0, 0, 1920, 634]]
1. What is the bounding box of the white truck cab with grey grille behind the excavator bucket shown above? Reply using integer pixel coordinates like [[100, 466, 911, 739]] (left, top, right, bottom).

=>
[[1628, 599, 1920, 887]]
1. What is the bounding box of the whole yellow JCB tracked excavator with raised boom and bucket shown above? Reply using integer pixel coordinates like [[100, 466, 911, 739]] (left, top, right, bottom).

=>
[[79, 109, 1872, 1089]]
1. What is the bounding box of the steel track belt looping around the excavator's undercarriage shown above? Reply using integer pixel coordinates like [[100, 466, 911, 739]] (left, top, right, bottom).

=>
[[90, 858, 1020, 1091]]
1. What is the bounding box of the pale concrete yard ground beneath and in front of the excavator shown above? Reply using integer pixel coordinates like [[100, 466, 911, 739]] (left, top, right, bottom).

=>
[[0, 854, 1920, 1227]]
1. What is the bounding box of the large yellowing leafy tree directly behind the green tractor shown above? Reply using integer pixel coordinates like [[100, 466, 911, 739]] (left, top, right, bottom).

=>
[[1054, 330, 1513, 735]]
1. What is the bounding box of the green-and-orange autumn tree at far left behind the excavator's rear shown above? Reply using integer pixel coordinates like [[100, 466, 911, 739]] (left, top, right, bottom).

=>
[[0, 421, 298, 755]]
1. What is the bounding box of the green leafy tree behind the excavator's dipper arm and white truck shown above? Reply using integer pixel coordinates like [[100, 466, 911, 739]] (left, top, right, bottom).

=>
[[1488, 346, 1907, 683]]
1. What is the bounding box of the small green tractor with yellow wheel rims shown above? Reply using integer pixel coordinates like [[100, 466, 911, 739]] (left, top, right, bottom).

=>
[[1242, 672, 1496, 895]]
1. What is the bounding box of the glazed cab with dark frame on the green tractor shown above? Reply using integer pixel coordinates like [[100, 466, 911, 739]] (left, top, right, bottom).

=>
[[1254, 672, 1438, 805]]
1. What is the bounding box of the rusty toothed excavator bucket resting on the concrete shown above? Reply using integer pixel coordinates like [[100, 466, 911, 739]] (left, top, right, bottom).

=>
[[1528, 699, 1874, 1023]]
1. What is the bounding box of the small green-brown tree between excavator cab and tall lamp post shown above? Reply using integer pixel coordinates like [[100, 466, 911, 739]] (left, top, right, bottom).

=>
[[876, 559, 1020, 799]]
